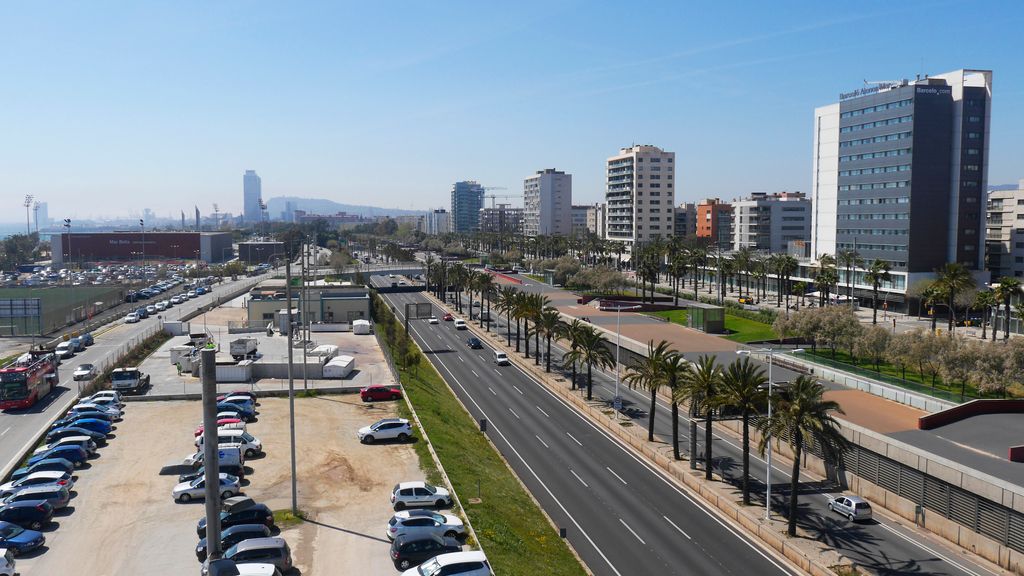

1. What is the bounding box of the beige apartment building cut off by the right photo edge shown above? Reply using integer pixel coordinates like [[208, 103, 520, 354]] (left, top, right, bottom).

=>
[[985, 180, 1024, 282]]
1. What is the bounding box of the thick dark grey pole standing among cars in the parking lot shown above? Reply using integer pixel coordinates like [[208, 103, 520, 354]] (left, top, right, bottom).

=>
[[200, 348, 222, 560]]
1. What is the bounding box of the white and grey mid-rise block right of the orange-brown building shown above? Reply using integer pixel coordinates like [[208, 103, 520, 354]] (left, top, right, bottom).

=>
[[732, 192, 811, 254]]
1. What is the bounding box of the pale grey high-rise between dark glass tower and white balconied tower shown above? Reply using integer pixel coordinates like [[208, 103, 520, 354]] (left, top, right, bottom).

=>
[[522, 168, 572, 236]]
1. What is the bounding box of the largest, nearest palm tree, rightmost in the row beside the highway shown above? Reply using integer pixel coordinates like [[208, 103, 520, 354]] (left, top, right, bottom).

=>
[[758, 374, 849, 536]]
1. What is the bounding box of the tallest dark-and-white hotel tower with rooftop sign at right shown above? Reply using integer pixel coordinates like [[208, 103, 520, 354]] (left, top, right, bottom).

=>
[[811, 70, 992, 290]]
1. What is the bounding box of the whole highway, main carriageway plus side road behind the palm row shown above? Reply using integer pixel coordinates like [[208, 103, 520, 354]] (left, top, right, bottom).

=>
[[375, 279, 998, 576]]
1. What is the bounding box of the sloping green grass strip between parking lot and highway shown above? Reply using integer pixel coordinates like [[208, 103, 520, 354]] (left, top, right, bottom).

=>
[[387, 342, 585, 576]]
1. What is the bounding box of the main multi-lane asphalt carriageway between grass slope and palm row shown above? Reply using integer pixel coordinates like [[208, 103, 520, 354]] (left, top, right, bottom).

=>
[[374, 278, 800, 576]]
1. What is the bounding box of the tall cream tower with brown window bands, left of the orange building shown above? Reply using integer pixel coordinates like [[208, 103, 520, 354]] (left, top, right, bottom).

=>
[[605, 146, 676, 246]]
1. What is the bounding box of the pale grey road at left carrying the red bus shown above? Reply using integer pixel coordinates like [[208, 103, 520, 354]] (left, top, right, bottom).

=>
[[0, 270, 274, 477]]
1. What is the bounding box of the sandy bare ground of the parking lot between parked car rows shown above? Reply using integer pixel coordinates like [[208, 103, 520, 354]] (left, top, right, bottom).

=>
[[17, 395, 423, 576]]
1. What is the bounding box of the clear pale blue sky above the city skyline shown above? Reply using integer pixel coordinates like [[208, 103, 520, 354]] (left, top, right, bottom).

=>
[[0, 0, 1024, 222]]
